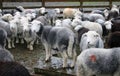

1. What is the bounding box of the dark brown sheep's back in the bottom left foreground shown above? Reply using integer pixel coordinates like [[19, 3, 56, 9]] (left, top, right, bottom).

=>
[[0, 62, 31, 76]]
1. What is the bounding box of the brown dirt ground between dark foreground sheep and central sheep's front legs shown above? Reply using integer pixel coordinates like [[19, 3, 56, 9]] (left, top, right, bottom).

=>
[[9, 41, 45, 76]]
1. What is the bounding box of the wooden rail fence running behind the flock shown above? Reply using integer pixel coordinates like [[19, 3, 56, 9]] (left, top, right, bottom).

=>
[[0, 0, 120, 9]]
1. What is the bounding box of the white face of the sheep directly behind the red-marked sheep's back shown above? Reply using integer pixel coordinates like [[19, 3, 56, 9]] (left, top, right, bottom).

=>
[[81, 31, 100, 48]]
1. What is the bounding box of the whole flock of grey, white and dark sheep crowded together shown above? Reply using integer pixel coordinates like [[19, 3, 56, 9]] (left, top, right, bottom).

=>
[[0, 5, 120, 76]]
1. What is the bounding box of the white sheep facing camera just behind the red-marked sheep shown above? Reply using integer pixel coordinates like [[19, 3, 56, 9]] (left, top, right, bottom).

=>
[[79, 31, 104, 51]]
